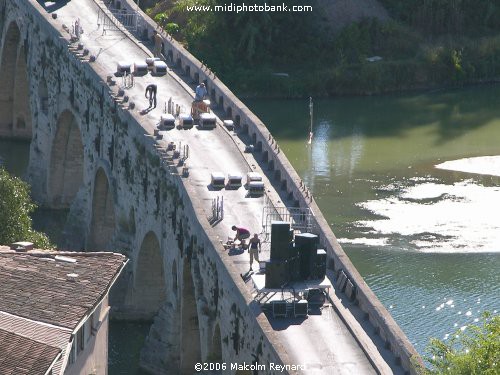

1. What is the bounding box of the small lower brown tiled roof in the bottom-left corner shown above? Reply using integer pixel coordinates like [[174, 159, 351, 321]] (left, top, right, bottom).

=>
[[0, 329, 61, 375]]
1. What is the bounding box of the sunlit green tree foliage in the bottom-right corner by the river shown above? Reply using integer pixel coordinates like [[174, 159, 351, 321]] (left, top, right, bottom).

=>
[[421, 312, 500, 375]]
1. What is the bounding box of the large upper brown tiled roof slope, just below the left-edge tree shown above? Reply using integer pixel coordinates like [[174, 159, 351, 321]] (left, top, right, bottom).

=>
[[0, 251, 126, 330]]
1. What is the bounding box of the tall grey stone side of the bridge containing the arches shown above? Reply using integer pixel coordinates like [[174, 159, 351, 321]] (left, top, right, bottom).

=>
[[0, 0, 287, 374]]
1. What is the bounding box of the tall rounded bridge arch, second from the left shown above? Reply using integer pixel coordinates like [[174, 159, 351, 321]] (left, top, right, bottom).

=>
[[47, 110, 84, 208]]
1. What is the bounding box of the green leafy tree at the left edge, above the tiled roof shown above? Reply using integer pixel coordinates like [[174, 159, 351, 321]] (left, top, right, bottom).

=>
[[0, 167, 53, 249]]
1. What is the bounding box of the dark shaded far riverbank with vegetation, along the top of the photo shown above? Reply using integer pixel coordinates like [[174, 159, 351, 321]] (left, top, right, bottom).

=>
[[148, 0, 500, 98]]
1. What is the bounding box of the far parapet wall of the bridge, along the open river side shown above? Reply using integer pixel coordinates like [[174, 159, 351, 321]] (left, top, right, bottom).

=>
[[111, 0, 421, 373]]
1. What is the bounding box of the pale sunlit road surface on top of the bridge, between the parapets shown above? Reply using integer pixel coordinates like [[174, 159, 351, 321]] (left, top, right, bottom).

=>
[[50, 0, 388, 375]]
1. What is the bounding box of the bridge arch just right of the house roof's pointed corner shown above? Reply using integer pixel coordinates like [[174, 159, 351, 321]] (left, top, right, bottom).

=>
[[134, 231, 167, 319]]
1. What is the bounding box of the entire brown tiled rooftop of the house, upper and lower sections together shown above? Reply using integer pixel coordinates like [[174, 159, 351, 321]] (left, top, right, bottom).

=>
[[0, 246, 127, 375]]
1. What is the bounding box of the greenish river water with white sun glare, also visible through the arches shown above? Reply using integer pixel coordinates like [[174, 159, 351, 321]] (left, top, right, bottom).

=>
[[0, 86, 500, 368]]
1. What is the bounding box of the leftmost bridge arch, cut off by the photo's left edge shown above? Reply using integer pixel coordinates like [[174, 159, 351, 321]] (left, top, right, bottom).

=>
[[0, 21, 32, 140]]
